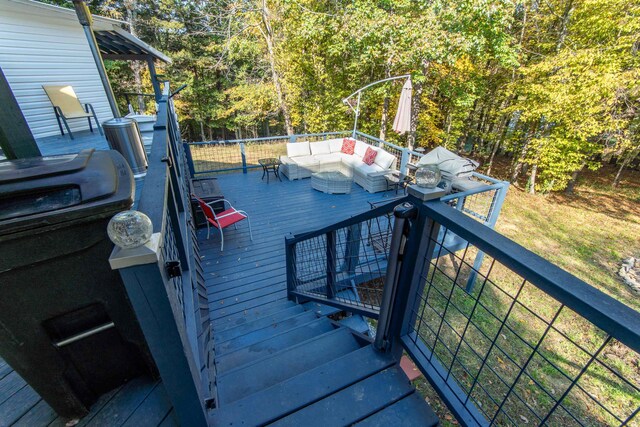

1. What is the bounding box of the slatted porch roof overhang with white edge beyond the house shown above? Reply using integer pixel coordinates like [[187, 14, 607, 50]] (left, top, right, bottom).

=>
[[93, 26, 171, 63]]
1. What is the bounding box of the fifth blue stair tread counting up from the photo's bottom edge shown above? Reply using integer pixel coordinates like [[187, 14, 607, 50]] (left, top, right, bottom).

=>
[[216, 317, 334, 373]]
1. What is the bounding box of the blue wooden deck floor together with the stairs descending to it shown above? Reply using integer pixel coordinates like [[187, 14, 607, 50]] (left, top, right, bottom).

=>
[[199, 172, 438, 426]]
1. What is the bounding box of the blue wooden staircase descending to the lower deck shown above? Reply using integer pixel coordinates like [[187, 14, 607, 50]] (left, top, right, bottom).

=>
[[210, 299, 438, 426]]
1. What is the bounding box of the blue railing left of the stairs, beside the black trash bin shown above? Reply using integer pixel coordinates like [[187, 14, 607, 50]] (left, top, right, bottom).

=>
[[111, 83, 211, 425]]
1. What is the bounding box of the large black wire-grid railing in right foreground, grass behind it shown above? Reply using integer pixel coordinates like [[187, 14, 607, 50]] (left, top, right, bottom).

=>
[[287, 196, 640, 426]]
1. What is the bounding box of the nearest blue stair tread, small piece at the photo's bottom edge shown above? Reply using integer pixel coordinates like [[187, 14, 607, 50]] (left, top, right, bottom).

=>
[[356, 393, 438, 427]]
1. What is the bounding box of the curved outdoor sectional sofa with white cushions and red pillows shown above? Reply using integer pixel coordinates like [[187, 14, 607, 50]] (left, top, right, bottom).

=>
[[280, 138, 396, 193]]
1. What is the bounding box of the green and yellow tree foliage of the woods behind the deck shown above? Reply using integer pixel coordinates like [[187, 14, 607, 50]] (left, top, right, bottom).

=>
[[51, 0, 640, 192]]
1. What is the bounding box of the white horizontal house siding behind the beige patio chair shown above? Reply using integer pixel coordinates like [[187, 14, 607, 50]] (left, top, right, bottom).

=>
[[0, 0, 113, 138]]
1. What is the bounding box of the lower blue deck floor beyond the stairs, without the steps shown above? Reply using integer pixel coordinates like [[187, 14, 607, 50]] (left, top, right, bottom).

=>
[[198, 172, 393, 320]]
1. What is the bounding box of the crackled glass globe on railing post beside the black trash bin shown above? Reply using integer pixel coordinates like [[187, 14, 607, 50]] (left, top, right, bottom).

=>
[[107, 211, 153, 249]]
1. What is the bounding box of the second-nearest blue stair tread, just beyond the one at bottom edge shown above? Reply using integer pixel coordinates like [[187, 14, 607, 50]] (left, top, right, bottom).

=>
[[270, 365, 415, 426]]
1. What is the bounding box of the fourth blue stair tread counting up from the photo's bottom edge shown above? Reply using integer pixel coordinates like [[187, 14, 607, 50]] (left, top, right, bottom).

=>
[[217, 328, 360, 406]]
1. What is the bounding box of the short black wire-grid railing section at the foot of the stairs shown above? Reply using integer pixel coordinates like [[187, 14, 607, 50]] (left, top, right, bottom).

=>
[[285, 201, 404, 318]]
